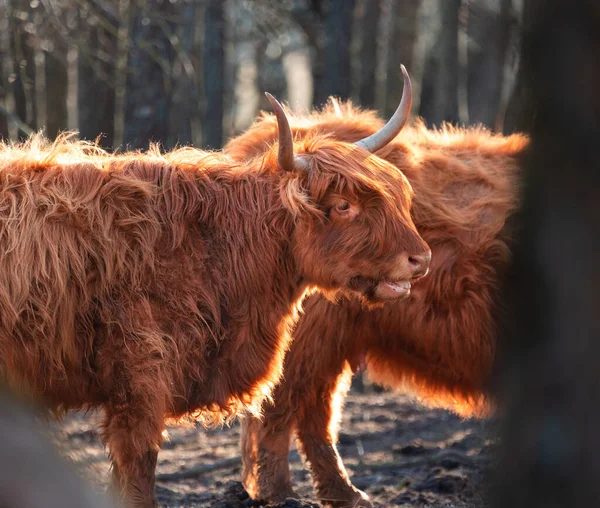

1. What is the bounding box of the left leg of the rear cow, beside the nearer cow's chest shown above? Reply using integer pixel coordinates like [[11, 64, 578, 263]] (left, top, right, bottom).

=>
[[241, 409, 298, 502]]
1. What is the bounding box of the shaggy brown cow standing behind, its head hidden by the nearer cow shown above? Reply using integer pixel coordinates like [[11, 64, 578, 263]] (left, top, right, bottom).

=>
[[225, 101, 527, 506]]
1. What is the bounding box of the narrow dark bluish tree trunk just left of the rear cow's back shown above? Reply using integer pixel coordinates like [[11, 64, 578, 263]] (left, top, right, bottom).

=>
[[202, 0, 225, 149]]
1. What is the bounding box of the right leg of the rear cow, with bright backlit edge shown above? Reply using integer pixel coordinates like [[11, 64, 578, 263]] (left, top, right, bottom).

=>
[[298, 364, 372, 507]]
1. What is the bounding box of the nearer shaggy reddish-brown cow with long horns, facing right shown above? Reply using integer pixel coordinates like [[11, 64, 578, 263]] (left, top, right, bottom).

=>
[[0, 81, 430, 506]]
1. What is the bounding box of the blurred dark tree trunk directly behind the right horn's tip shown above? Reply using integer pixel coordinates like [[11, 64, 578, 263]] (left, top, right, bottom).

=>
[[385, 0, 421, 118]]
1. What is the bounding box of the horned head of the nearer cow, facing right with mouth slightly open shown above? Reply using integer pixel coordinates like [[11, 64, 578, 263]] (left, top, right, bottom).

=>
[[266, 67, 431, 304]]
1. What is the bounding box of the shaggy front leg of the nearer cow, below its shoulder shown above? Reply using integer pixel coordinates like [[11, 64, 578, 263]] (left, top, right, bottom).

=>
[[97, 300, 171, 508]]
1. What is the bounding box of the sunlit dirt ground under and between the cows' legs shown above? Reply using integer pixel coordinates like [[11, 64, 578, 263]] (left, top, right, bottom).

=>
[[52, 384, 494, 508]]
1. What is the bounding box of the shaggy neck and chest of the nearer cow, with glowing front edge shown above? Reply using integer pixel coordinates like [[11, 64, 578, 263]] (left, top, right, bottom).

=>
[[183, 170, 306, 408]]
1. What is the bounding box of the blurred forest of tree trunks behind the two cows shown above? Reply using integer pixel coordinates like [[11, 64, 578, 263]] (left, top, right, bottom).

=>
[[0, 0, 523, 149]]
